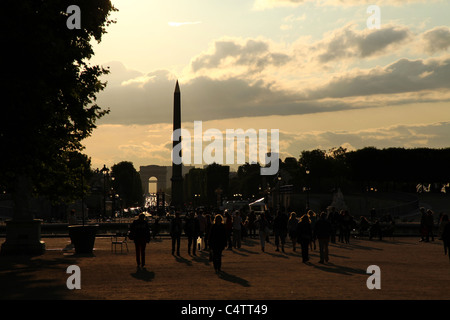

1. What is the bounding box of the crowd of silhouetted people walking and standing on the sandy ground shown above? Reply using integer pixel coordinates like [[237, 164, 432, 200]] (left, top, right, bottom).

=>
[[127, 208, 450, 273]]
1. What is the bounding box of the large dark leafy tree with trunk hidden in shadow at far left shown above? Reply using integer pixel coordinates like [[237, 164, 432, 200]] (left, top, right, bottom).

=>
[[0, 0, 116, 214]]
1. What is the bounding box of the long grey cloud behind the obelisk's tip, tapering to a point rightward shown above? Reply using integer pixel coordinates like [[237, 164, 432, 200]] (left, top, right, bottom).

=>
[[97, 61, 358, 125]]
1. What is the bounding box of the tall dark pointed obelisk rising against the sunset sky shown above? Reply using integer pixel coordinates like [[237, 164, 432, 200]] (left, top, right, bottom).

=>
[[170, 80, 183, 209]]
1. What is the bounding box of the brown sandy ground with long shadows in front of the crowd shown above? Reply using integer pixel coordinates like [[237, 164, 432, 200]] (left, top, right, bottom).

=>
[[0, 237, 450, 300]]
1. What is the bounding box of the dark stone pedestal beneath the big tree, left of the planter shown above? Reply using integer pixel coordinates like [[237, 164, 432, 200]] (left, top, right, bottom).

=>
[[1, 219, 45, 255]]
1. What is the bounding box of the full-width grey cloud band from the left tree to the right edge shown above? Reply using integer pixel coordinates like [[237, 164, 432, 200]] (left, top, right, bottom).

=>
[[98, 50, 450, 124]]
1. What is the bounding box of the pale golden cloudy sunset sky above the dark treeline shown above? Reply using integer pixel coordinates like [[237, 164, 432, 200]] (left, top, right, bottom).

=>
[[81, 0, 450, 170]]
